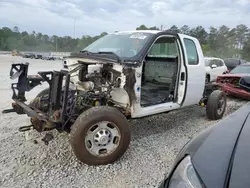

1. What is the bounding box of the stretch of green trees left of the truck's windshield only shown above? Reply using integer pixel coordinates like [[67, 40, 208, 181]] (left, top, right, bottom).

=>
[[0, 27, 107, 52]]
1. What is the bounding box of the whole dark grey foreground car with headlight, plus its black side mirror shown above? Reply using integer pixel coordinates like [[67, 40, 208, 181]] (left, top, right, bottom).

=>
[[160, 82, 250, 188]]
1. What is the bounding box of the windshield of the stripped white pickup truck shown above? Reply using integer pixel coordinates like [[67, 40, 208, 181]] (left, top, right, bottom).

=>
[[83, 32, 154, 58]]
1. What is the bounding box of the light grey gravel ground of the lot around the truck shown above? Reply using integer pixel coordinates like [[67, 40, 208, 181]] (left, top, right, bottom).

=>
[[0, 55, 246, 188]]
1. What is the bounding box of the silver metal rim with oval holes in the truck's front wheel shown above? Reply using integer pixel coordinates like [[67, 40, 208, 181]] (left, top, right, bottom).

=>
[[85, 121, 121, 157]]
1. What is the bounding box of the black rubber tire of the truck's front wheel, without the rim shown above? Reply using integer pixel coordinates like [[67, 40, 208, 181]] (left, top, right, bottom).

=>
[[70, 106, 131, 165]]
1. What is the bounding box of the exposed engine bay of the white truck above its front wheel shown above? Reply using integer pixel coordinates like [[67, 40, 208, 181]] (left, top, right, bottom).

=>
[[64, 60, 126, 112]]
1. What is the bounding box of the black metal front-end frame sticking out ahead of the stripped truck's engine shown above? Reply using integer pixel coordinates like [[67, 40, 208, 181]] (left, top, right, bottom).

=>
[[3, 63, 82, 132]]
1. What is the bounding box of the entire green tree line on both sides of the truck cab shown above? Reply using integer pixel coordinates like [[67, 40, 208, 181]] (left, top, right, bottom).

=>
[[0, 24, 250, 60]]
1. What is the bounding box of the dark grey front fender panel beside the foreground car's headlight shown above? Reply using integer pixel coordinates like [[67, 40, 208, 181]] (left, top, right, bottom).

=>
[[172, 103, 250, 188]]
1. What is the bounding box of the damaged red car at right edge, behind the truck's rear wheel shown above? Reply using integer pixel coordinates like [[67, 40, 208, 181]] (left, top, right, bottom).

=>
[[216, 63, 250, 100]]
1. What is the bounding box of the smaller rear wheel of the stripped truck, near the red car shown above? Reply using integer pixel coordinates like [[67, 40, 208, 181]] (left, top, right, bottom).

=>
[[206, 90, 227, 120]]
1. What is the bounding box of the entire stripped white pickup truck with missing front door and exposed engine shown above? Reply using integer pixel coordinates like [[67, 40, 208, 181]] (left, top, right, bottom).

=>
[[3, 30, 226, 165]]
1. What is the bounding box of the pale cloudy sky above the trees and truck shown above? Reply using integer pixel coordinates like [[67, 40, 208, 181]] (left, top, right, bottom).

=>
[[0, 0, 250, 37]]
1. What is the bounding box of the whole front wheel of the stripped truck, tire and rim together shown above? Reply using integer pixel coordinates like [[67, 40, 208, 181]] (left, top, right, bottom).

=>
[[70, 106, 131, 165]]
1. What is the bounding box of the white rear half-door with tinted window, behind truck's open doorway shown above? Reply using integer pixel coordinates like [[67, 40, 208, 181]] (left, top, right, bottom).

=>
[[179, 34, 206, 106]]
